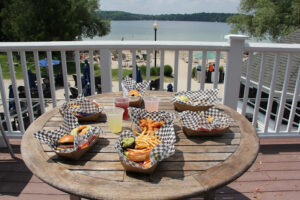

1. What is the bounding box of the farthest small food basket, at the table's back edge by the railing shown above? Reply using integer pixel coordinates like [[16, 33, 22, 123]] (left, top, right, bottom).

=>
[[121, 76, 150, 107]]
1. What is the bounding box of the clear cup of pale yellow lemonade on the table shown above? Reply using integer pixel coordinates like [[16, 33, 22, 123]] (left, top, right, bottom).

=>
[[106, 107, 124, 133]]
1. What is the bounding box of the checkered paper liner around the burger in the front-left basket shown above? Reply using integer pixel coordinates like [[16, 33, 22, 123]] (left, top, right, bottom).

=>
[[33, 110, 102, 153]]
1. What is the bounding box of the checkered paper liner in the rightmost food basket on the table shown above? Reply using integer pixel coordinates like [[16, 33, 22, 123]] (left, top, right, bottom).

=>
[[178, 108, 233, 131]]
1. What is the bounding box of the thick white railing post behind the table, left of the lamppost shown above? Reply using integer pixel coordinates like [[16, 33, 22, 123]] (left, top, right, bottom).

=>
[[100, 49, 112, 93]]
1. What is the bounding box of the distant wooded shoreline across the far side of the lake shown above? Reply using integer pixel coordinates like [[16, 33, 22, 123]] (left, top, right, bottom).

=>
[[98, 11, 233, 22]]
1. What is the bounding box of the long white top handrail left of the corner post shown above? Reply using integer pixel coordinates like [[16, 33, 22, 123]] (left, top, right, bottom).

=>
[[0, 41, 230, 52]]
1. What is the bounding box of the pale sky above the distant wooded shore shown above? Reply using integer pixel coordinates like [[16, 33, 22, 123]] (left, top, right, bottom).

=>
[[99, 0, 240, 14]]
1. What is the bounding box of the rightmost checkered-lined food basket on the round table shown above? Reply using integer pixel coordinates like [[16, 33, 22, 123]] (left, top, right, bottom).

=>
[[179, 108, 232, 136]]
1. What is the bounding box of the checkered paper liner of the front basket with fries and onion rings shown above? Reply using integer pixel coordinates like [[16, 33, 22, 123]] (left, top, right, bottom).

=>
[[115, 127, 175, 169]]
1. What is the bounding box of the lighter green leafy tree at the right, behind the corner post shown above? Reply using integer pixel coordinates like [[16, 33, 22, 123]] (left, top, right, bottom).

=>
[[227, 0, 300, 41]]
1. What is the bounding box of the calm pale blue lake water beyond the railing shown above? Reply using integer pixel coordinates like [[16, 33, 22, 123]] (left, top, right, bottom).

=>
[[85, 21, 230, 42]]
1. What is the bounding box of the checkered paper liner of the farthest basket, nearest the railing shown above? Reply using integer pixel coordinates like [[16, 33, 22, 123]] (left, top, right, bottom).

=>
[[121, 76, 150, 97]]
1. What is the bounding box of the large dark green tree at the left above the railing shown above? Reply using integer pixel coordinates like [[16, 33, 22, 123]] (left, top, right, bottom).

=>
[[0, 0, 110, 41]]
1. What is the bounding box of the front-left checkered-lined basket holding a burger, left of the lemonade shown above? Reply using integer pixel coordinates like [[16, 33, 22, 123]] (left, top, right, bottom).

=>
[[34, 110, 102, 160]]
